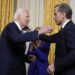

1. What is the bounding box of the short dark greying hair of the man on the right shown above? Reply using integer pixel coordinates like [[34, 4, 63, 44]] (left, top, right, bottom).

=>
[[55, 3, 72, 19]]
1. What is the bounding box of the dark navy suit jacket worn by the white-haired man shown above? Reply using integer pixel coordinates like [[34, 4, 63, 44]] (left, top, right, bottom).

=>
[[0, 22, 38, 75]]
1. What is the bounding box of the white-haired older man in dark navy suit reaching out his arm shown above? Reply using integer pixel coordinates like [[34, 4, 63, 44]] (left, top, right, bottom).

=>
[[0, 9, 51, 75]]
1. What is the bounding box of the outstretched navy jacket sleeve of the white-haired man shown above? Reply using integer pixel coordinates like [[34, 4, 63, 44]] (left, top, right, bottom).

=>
[[7, 28, 38, 43]]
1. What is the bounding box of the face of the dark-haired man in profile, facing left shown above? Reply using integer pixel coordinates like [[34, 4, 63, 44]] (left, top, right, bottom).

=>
[[54, 7, 65, 25]]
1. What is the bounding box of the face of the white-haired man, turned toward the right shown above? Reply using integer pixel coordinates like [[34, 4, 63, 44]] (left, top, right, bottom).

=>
[[20, 11, 29, 28]]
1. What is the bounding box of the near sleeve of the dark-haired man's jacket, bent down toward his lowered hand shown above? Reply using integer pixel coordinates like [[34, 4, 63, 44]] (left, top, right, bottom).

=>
[[55, 28, 75, 73]]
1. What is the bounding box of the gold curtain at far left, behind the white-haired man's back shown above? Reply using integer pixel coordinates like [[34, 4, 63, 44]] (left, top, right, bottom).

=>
[[0, 0, 14, 33]]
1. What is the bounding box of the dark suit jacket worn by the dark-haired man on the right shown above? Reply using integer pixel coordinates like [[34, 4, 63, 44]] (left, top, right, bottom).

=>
[[40, 21, 75, 75]]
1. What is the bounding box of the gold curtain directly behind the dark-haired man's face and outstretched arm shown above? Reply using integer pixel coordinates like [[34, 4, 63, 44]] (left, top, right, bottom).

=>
[[44, 0, 68, 64]]
